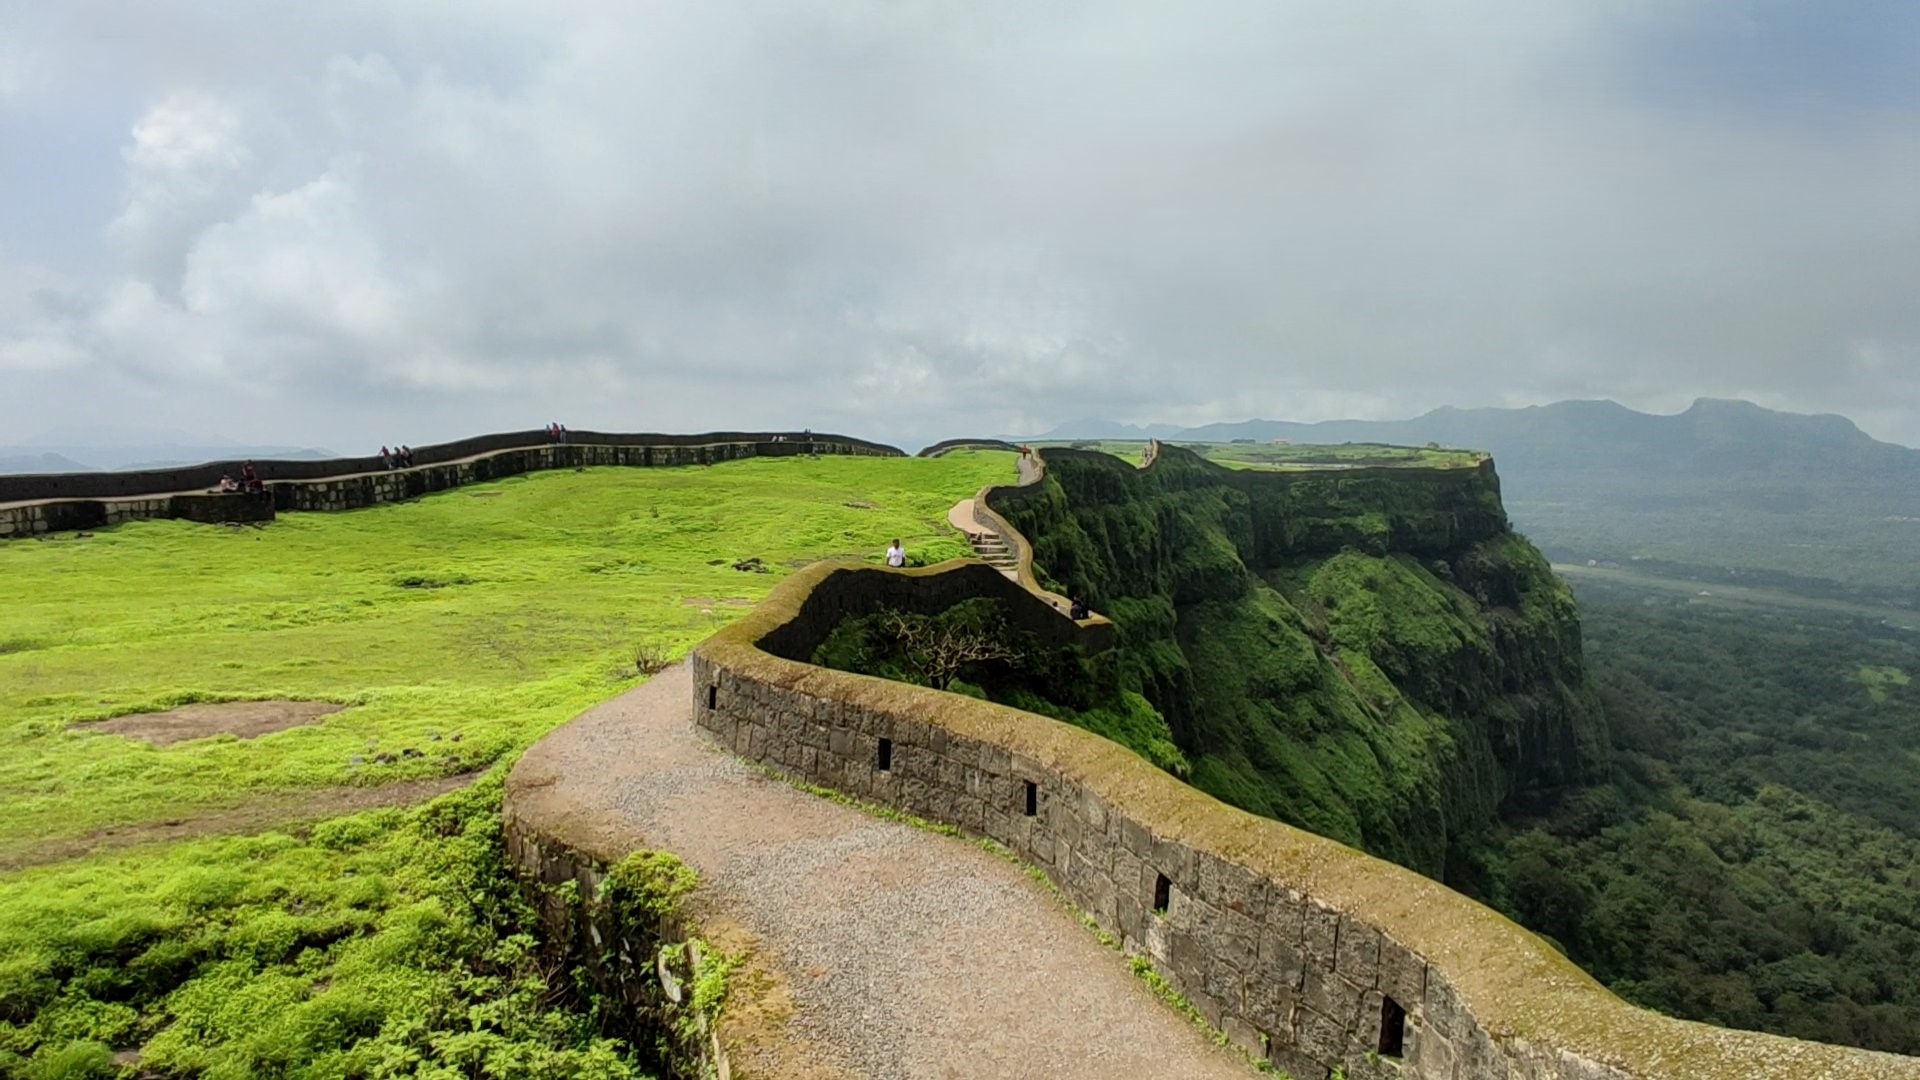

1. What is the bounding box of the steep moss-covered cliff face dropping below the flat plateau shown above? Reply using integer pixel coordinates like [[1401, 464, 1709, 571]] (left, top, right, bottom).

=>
[[989, 448, 1605, 878]]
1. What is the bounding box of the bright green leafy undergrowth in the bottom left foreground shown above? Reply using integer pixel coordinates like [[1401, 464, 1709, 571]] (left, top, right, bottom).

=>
[[0, 773, 656, 1080]]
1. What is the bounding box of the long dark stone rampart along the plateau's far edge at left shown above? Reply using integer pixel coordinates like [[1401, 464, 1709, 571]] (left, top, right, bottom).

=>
[[0, 432, 902, 538]]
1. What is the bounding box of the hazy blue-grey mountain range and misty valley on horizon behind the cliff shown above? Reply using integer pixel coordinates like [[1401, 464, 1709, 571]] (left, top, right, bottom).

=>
[[1031, 398, 1920, 591]]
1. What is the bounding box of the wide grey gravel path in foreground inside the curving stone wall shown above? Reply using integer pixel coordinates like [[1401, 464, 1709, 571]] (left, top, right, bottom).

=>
[[509, 667, 1252, 1080]]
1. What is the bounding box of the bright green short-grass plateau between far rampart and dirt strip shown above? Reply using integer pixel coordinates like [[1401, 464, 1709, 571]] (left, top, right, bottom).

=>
[[0, 454, 1012, 855]]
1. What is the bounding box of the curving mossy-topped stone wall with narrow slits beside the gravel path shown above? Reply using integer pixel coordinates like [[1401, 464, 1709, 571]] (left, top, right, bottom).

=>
[[693, 563, 1920, 1080]]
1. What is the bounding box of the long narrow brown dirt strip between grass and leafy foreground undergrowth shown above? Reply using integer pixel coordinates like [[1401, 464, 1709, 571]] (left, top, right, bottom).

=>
[[0, 771, 482, 874]]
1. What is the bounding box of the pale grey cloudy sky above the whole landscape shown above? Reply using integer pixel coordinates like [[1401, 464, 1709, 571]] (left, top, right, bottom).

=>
[[0, 0, 1920, 452]]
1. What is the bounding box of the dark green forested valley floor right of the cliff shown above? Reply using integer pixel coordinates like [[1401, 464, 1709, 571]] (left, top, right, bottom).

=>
[[1488, 586, 1920, 1053]]
